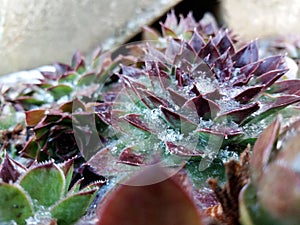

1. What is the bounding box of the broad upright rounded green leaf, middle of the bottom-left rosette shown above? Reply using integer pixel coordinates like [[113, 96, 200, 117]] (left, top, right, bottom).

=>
[[19, 162, 66, 207]]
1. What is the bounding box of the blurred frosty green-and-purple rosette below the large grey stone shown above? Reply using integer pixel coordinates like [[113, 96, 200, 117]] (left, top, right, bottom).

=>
[[1, 49, 117, 111]]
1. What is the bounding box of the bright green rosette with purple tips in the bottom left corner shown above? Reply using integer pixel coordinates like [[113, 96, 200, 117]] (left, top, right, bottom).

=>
[[0, 154, 103, 225]]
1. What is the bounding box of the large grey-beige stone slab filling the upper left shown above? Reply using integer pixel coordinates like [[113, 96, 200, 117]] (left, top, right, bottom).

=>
[[0, 0, 180, 75]]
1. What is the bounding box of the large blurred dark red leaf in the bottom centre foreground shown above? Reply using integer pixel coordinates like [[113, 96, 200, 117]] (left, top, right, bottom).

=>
[[97, 168, 202, 225]]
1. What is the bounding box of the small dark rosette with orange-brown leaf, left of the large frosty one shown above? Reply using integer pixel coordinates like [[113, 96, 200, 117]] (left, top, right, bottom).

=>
[[21, 99, 114, 162]]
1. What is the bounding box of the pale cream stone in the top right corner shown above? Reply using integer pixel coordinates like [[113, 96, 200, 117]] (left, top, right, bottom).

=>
[[220, 0, 300, 40]]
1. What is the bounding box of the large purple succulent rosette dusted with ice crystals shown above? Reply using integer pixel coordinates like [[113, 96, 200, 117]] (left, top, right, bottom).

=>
[[89, 11, 300, 183]]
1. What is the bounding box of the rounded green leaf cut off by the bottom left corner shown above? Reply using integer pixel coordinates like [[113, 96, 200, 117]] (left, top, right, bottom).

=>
[[0, 183, 33, 225]]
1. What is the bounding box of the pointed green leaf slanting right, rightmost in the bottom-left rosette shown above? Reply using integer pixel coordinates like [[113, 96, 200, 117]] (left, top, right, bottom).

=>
[[51, 189, 97, 225]]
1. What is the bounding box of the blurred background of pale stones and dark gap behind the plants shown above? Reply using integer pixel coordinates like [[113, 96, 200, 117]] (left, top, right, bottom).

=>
[[0, 0, 300, 75]]
